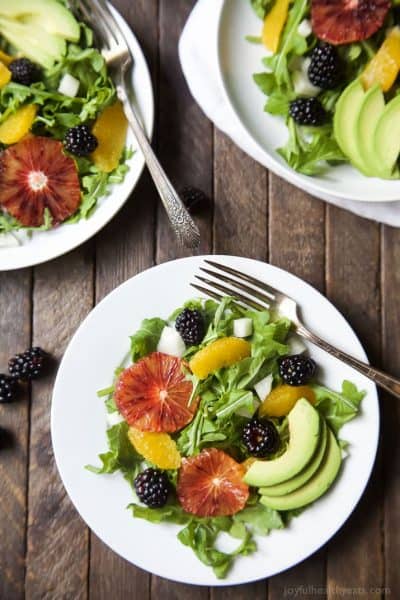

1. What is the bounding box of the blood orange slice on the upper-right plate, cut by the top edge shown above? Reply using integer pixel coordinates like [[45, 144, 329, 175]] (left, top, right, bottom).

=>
[[311, 0, 391, 44]]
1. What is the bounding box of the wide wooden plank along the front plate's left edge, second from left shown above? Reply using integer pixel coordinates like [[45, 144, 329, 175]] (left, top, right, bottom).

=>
[[26, 244, 93, 600]]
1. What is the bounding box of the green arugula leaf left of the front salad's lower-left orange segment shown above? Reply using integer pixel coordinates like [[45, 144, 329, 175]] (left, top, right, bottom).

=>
[[86, 421, 143, 486]]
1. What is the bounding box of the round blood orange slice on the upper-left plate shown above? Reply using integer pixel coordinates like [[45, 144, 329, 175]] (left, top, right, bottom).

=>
[[0, 136, 81, 227]]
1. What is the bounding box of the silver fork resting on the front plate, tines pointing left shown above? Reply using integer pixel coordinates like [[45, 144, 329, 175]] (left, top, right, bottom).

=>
[[191, 260, 400, 398]]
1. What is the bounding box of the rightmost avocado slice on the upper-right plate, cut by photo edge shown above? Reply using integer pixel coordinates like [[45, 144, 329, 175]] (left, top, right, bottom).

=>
[[373, 96, 400, 179]]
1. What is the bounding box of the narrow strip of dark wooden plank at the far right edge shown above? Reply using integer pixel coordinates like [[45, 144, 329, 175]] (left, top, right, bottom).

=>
[[381, 227, 400, 596]]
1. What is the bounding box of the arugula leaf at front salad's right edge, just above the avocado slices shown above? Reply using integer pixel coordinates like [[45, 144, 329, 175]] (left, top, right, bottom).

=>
[[311, 380, 365, 434]]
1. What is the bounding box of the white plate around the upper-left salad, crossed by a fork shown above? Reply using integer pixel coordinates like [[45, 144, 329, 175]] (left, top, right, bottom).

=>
[[0, 7, 154, 271]]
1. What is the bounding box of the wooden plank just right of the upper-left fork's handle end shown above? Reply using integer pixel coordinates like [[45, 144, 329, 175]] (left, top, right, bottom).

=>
[[211, 131, 268, 600]]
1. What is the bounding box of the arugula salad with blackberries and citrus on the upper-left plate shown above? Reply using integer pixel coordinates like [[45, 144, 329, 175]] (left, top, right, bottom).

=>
[[0, 0, 131, 242]]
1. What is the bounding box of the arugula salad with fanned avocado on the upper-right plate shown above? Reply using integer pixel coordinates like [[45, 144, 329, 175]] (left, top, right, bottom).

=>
[[248, 0, 400, 179]]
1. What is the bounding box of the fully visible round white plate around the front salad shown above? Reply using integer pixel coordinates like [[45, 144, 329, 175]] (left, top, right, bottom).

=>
[[51, 256, 379, 585]]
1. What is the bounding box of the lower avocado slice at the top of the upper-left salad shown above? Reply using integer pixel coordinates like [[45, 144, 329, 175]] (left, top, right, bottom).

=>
[[0, 16, 66, 68]]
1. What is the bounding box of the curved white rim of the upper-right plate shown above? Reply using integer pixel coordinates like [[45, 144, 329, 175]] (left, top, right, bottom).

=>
[[215, 0, 400, 203]]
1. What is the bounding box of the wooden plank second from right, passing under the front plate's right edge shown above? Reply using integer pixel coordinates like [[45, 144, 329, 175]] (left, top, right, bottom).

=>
[[327, 207, 383, 598]]
